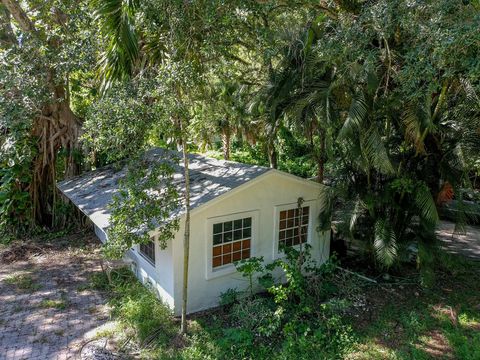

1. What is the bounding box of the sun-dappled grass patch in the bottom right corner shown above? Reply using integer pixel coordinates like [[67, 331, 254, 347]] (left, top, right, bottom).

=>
[[348, 255, 480, 360]]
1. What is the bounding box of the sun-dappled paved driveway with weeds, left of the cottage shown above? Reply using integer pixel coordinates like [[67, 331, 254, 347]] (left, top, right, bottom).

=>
[[0, 234, 112, 360]]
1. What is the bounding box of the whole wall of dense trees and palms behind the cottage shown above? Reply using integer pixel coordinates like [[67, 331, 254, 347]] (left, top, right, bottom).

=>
[[0, 0, 480, 283]]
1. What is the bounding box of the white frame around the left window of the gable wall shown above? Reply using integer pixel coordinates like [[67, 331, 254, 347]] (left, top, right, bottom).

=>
[[205, 210, 259, 280]]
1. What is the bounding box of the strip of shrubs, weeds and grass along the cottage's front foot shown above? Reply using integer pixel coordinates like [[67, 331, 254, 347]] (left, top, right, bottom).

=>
[[90, 249, 480, 360]]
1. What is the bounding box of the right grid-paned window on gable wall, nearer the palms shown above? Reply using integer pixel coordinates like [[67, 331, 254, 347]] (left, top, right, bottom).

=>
[[278, 206, 310, 249]]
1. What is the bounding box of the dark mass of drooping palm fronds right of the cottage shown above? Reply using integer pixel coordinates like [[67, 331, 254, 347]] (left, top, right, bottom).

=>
[[263, 0, 479, 282]]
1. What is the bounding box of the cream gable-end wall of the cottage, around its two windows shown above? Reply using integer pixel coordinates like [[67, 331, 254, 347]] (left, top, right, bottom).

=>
[[173, 171, 330, 315]]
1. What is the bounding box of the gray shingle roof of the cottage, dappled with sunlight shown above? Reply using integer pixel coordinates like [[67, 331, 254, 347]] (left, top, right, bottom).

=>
[[57, 148, 270, 229]]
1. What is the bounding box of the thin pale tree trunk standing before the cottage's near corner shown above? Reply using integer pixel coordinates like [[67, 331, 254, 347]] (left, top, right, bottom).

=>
[[180, 123, 190, 334]]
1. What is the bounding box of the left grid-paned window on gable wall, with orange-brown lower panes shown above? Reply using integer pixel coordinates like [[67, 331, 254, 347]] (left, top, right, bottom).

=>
[[212, 217, 252, 268]]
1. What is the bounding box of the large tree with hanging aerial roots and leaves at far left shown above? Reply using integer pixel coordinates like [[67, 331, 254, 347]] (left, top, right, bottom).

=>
[[0, 0, 95, 233]]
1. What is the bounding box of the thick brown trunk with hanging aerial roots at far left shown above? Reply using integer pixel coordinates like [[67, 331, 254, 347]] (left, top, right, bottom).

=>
[[0, 0, 81, 225]]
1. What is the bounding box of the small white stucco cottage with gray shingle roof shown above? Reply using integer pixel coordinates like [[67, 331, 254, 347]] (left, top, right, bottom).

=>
[[58, 149, 330, 315]]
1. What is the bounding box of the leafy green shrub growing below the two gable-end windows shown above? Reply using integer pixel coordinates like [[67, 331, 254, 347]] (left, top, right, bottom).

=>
[[222, 245, 355, 359]]
